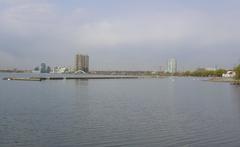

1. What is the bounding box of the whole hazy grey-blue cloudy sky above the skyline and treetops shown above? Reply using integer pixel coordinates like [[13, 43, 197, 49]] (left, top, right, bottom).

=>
[[0, 0, 240, 70]]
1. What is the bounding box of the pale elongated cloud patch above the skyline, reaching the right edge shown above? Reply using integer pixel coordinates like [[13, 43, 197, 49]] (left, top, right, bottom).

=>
[[70, 12, 240, 47]]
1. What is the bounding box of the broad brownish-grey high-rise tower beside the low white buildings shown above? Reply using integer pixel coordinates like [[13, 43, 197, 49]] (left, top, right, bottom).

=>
[[75, 54, 89, 72]]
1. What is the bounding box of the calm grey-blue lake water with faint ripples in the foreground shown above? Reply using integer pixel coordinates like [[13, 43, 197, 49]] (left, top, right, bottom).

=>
[[0, 74, 240, 147]]
